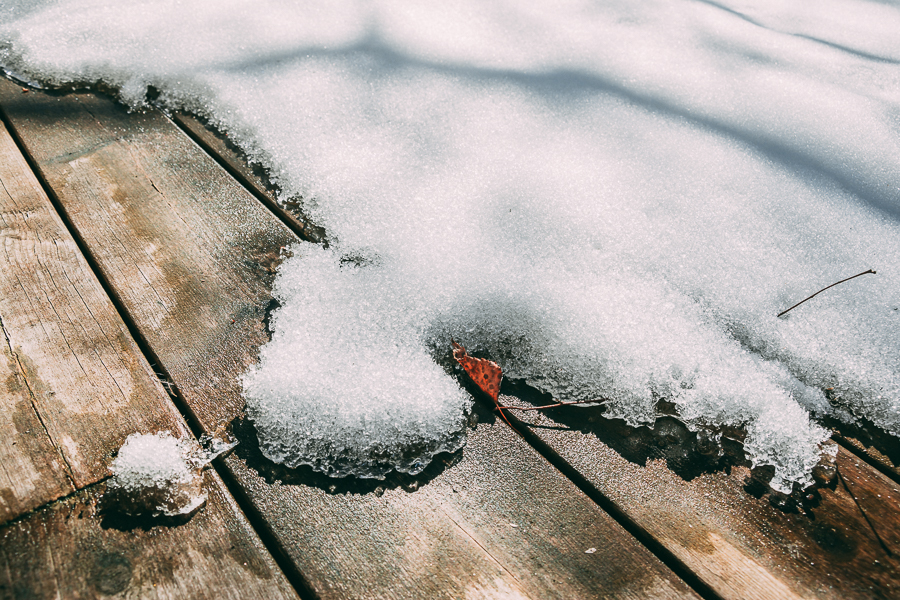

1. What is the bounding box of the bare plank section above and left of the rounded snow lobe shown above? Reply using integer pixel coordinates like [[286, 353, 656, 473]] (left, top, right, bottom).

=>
[[0, 82, 286, 430]]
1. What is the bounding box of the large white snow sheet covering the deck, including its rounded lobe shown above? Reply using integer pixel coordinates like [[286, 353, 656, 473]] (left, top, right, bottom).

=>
[[0, 0, 900, 491]]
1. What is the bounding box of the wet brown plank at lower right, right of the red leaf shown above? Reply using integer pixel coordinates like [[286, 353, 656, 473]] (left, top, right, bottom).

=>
[[501, 396, 900, 599]]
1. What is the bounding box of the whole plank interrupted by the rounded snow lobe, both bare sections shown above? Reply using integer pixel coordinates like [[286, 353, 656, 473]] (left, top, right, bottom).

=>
[[0, 81, 693, 598]]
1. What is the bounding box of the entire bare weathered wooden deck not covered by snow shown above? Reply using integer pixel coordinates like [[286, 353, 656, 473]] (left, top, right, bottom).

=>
[[0, 80, 900, 599]]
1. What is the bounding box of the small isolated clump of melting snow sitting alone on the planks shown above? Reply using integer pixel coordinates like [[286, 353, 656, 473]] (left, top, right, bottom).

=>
[[105, 432, 234, 517]]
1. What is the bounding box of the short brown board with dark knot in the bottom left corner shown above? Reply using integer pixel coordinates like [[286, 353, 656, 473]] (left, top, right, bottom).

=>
[[0, 472, 297, 600]]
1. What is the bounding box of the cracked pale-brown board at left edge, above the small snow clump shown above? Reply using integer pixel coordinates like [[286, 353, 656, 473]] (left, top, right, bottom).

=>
[[0, 115, 181, 523]]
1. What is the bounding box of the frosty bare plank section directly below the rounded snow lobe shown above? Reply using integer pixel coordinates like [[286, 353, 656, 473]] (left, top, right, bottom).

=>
[[228, 398, 686, 598]]
